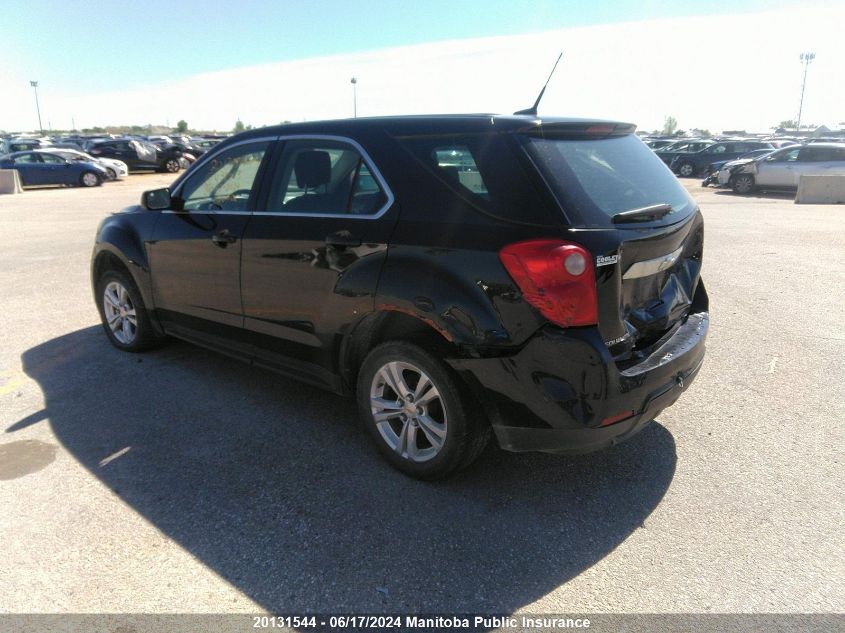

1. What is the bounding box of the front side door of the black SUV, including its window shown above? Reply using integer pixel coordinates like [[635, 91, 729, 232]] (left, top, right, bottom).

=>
[[147, 140, 272, 357]]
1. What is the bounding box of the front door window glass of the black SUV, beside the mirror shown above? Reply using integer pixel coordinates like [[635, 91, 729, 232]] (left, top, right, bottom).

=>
[[181, 141, 270, 211]]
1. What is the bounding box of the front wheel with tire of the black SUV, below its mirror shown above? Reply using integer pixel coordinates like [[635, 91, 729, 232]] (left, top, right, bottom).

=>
[[97, 270, 160, 352]]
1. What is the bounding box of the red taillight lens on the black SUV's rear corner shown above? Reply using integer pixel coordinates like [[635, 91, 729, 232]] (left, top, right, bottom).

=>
[[499, 240, 598, 327]]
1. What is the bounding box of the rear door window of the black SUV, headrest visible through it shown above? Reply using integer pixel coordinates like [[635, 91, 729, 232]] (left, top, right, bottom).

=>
[[267, 140, 387, 215]]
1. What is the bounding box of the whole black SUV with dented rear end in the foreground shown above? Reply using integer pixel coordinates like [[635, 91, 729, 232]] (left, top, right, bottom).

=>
[[92, 115, 708, 478]]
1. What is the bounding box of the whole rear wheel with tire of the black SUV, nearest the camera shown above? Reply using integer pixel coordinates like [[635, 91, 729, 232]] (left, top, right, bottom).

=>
[[357, 341, 490, 479]]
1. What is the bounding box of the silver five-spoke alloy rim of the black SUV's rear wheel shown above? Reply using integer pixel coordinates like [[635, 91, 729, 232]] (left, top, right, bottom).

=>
[[370, 361, 447, 462]]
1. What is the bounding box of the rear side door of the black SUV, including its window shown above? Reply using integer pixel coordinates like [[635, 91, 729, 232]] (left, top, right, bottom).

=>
[[237, 137, 397, 388]]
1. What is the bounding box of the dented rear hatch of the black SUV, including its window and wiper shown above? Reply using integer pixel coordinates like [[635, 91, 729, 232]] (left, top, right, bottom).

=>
[[521, 123, 704, 364]]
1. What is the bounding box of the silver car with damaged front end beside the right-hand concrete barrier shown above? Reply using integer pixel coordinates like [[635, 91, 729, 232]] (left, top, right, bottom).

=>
[[719, 143, 845, 193]]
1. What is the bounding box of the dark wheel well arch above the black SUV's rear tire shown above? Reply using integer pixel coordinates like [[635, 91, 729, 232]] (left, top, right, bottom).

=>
[[340, 311, 458, 390]]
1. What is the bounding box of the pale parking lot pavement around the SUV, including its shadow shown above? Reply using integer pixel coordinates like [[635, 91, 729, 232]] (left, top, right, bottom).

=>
[[0, 175, 845, 613]]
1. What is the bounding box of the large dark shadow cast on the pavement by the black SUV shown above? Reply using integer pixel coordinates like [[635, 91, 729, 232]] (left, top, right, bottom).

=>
[[16, 326, 676, 613]]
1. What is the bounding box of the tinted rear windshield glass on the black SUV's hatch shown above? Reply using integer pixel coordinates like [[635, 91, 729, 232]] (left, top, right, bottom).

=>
[[526, 134, 695, 226]]
